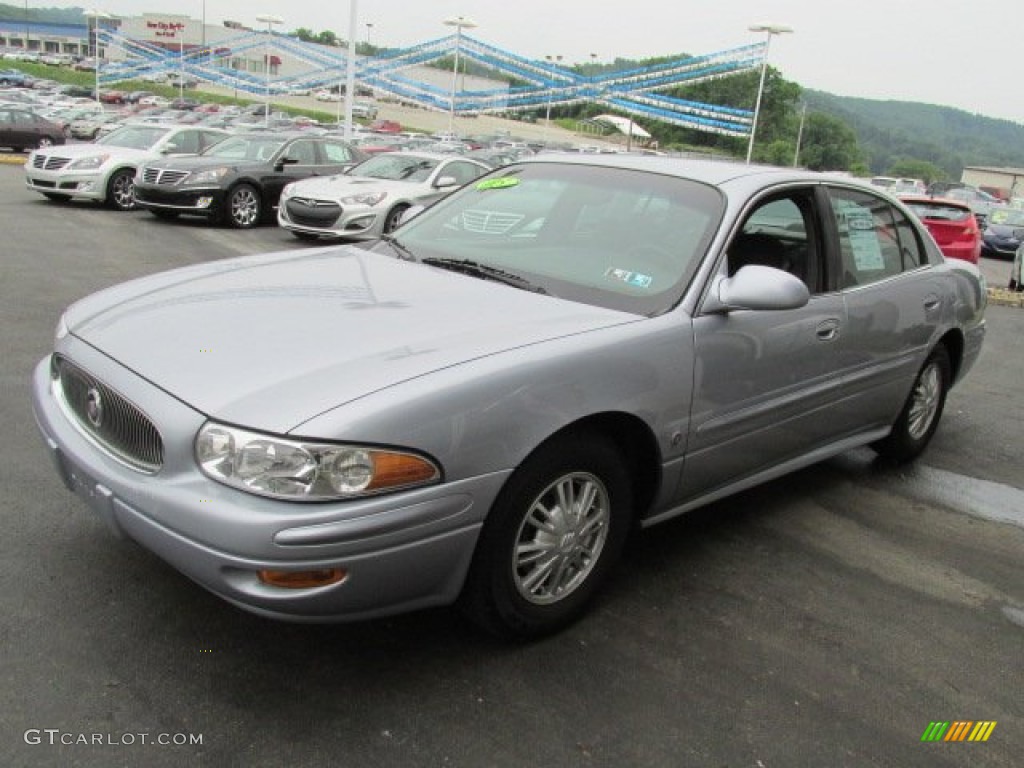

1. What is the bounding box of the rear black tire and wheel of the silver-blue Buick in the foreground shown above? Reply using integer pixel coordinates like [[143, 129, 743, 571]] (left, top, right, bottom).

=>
[[872, 344, 952, 464]]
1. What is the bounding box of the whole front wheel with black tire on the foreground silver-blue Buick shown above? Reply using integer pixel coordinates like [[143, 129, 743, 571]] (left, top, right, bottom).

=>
[[460, 433, 633, 638]]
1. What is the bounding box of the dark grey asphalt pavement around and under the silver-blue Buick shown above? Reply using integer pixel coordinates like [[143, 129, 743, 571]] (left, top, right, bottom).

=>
[[0, 159, 1024, 768]]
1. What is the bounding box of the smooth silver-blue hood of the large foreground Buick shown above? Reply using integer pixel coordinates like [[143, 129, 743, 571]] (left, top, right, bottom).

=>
[[65, 246, 638, 433]]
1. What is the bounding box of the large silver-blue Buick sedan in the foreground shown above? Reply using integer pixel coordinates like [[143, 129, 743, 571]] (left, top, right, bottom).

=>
[[34, 155, 986, 637]]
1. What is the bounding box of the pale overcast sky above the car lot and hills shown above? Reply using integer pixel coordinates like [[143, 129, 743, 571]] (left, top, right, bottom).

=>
[[70, 0, 1024, 123]]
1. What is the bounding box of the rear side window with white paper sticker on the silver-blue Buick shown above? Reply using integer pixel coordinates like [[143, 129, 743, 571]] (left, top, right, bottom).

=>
[[828, 187, 928, 288]]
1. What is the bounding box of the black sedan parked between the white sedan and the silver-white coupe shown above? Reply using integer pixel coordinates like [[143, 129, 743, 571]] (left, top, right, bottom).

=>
[[135, 133, 367, 229]]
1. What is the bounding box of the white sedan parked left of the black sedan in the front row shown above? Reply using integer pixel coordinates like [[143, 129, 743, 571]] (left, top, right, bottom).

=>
[[25, 124, 229, 211]]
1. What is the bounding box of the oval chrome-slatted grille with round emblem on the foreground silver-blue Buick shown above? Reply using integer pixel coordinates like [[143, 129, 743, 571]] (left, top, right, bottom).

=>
[[52, 355, 164, 473]]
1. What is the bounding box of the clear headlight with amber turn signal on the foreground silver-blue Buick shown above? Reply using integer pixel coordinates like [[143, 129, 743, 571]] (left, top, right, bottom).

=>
[[196, 422, 440, 501]]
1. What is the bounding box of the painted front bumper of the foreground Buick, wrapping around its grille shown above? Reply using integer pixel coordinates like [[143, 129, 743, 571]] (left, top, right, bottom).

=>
[[33, 340, 497, 622]]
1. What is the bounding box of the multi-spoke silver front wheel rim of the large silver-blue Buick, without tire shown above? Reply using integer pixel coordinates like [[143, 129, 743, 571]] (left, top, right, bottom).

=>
[[513, 472, 611, 605]]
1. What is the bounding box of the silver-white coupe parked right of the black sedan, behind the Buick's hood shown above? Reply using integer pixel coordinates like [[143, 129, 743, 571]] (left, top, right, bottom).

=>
[[278, 152, 490, 240]]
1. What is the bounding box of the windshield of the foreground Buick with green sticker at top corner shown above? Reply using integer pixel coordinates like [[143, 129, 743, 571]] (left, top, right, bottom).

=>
[[378, 163, 724, 315]]
